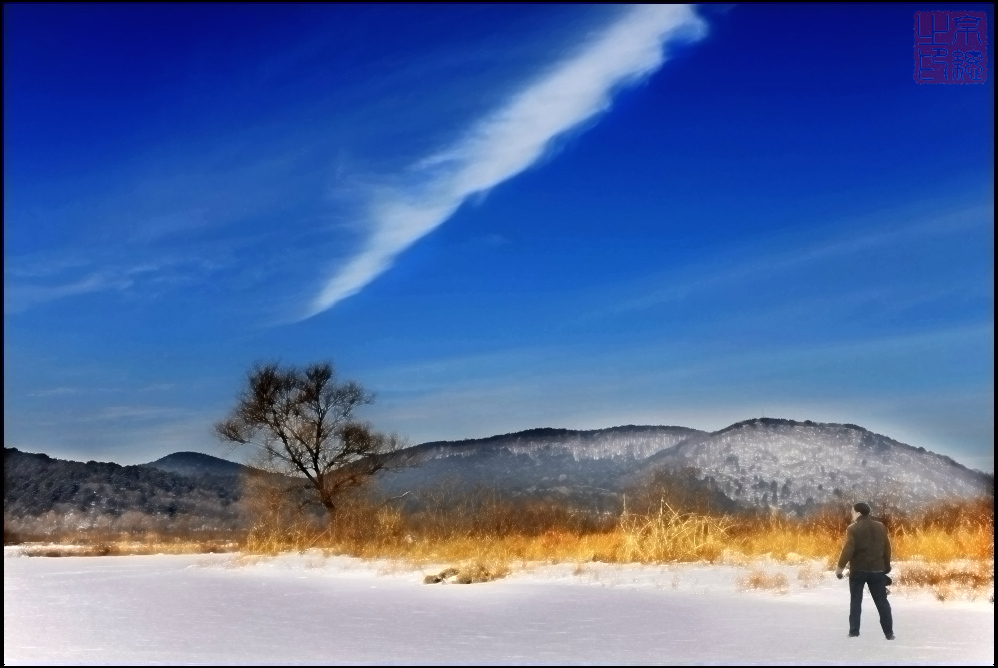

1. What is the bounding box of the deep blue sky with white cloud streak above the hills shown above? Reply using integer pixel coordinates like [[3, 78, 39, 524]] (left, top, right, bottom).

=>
[[3, 4, 994, 470]]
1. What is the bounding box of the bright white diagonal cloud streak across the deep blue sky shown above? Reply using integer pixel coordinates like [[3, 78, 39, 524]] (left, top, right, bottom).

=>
[[304, 5, 706, 318]]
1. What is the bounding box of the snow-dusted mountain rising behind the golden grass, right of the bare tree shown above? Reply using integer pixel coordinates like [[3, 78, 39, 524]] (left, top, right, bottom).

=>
[[379, 418, 987, 513]]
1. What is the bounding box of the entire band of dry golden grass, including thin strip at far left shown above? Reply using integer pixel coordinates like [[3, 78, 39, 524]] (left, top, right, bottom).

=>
[[11, 482, 994, 597]]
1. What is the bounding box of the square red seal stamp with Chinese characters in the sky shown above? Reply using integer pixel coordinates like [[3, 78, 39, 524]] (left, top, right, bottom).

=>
[[915, 10, 988, 84]]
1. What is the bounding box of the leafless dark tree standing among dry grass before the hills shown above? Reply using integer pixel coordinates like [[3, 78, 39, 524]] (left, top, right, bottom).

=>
[[215, 362, 403, 519]]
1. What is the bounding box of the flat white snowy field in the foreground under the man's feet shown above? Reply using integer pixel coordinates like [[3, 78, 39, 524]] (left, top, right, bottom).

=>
[[3, 548, 994, 665]]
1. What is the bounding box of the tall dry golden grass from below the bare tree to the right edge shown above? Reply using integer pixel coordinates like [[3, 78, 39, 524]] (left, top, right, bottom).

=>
[[232, 488, 994, 595]]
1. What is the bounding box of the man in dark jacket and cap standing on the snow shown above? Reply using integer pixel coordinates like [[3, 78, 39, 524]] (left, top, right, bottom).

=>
[[835, 503, 894, 640]]
